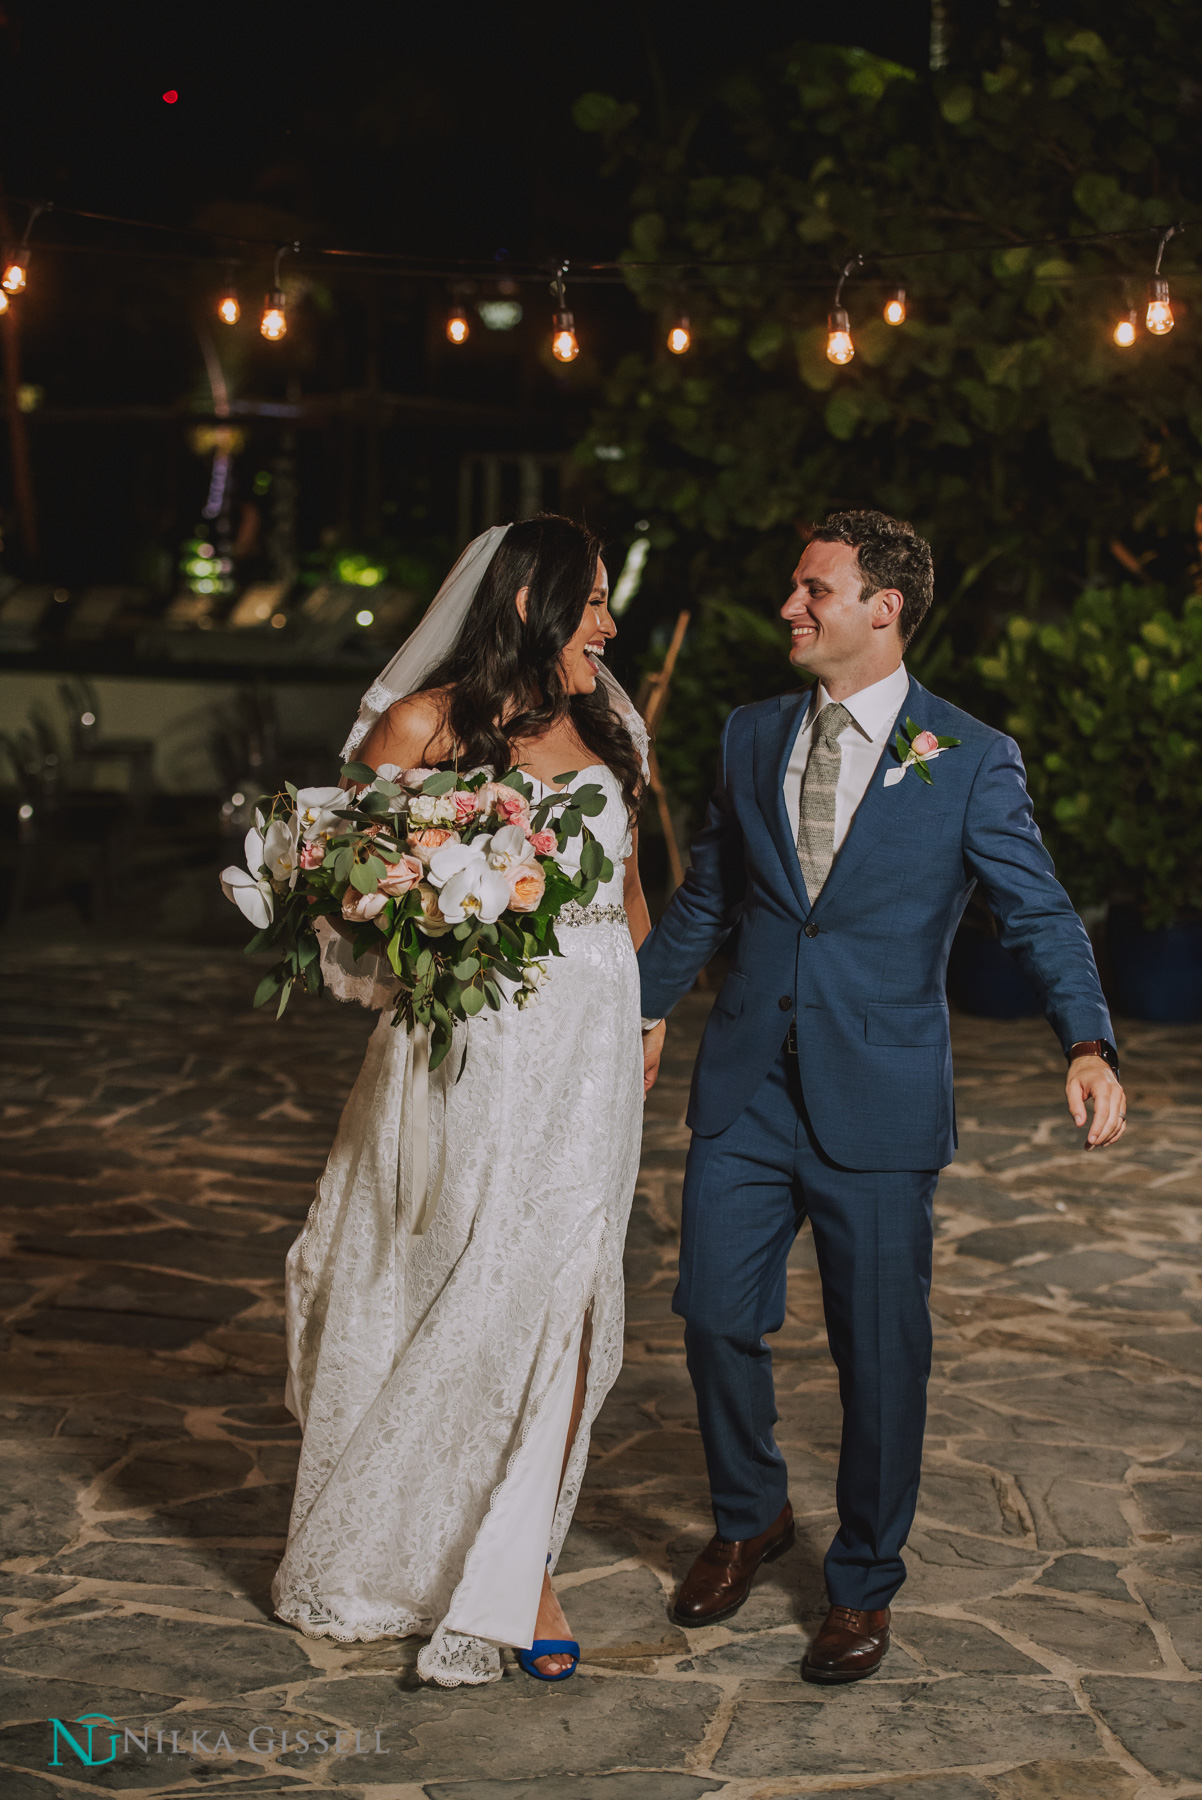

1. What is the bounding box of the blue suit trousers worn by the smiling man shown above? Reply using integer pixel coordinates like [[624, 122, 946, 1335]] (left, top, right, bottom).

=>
[[673, 1048, 937, 1609]]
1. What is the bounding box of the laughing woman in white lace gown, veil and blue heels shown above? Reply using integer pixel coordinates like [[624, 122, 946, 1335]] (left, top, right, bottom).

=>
[[272, 515, 650, 1687]]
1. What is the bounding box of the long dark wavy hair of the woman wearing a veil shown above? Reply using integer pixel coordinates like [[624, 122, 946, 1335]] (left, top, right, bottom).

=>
[[421, 513, 642, 815]]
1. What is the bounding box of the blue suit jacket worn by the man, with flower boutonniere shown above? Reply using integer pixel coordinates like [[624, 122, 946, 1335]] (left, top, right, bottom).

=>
[[639, 680, 1114, 1170]]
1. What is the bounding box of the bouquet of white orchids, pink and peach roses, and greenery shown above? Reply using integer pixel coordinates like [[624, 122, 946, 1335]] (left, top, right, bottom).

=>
[[221, 763, 614, 1069]]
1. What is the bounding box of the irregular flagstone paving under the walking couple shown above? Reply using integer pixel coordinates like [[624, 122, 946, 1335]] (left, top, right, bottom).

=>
[[0, 945, 1202, 1800]]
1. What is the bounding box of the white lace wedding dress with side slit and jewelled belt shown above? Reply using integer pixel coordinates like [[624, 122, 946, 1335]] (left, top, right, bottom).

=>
[[272, 767, 642, 1687]]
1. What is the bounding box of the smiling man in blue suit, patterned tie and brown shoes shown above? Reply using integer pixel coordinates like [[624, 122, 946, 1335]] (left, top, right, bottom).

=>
[[639, 511, 1126, 1681]]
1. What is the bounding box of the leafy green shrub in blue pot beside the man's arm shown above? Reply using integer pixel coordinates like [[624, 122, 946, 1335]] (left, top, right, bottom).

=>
[[977, 583, 1202, 1022]]
